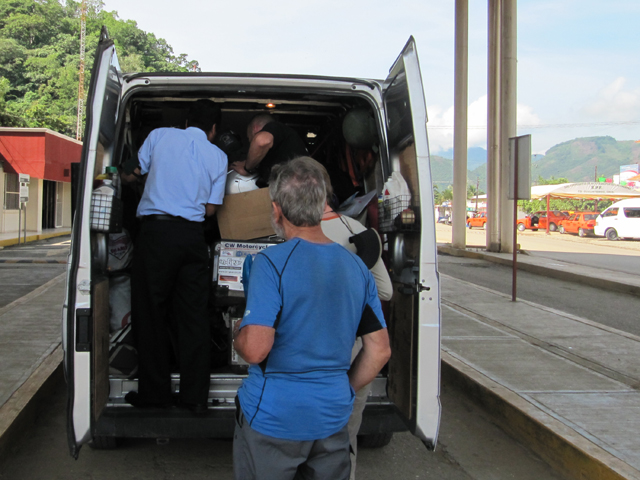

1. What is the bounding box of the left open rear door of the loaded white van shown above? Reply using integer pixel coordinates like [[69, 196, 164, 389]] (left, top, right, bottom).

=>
[[62, 27, 122, 458]]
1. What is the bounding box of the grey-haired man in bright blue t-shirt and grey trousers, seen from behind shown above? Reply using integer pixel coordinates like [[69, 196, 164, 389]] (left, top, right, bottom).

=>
[[234, 157, 391, 480]]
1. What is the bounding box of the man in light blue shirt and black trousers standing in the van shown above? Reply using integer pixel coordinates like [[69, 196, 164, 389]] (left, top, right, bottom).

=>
[[123, 100, 227, 414]]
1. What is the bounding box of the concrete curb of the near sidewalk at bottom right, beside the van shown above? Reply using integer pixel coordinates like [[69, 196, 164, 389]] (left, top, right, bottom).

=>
[[441, 351, 640, 480]]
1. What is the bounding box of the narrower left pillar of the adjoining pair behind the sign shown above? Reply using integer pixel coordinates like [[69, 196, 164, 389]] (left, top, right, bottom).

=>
[[486, 0, 502, 252]]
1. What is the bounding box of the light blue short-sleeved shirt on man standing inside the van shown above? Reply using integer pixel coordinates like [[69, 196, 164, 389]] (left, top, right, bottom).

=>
[[138, 127, 227, 222]]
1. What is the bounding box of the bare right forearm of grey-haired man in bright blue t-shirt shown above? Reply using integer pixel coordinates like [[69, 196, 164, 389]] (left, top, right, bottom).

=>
[[349, 328, 391, 392]]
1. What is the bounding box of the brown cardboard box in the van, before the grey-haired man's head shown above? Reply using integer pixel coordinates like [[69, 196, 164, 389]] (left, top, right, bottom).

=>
[[216, 188, 275, 240]]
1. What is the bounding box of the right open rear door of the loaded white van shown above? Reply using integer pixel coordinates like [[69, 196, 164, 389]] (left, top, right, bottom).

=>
[[383, 37, 440, 449]]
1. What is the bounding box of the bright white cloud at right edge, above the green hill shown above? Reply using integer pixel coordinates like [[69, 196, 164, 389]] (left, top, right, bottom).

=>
[[583, 77, 640, 122]]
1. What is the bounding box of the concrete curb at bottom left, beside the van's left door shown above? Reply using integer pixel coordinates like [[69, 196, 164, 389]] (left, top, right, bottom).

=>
[[0, 345, 64, 465]]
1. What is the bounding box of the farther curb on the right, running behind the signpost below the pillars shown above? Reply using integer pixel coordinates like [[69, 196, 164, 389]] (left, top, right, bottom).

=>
[[438, 245, 640, 296]]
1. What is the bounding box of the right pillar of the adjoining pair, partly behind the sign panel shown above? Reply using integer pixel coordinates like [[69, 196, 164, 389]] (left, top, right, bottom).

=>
[[500, 0, 517, 253]]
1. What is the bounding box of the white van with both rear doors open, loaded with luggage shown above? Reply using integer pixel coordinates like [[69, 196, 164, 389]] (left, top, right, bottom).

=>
[[62, 29, 440, 457]]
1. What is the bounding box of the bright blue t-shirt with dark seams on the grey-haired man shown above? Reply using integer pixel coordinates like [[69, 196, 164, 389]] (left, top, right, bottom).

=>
[[238, 238, 386, 440]]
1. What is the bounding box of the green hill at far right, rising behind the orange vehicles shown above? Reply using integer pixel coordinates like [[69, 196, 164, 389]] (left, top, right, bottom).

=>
[[531, 137, 640, 182]]
